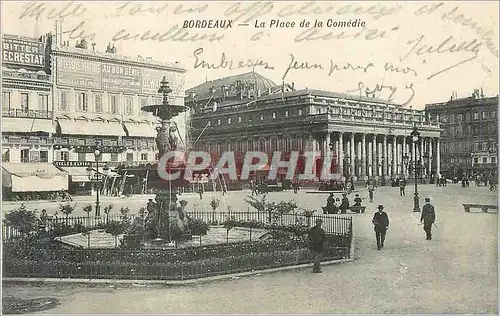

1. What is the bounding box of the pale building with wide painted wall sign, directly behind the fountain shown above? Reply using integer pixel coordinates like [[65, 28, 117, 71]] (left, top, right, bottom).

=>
[[50, 40, 186, 194]]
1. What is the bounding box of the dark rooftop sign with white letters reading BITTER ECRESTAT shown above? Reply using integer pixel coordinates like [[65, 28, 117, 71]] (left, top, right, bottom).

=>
[[2, 37, 45, 68]]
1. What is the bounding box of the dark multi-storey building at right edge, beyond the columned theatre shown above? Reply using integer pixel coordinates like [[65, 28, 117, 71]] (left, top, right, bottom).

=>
[[425, 89, 498, 178]]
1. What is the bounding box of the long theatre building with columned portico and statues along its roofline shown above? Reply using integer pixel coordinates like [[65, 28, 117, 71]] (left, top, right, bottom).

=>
[[186, 72, 441, 181]]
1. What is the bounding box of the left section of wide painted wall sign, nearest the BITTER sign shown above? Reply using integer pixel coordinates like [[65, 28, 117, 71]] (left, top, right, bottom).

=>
[[56, 57, 101, 89]]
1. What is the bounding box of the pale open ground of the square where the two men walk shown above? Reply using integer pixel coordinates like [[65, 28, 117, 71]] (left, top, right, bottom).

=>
[[3, 185, 498, 314]]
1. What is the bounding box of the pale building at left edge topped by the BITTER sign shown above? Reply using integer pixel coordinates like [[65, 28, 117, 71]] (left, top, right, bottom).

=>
[[1, 34, 68, 199]]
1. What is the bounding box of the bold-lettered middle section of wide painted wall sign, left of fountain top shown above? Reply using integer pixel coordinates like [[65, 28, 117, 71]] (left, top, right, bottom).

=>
[[101, 63, 141, 93]]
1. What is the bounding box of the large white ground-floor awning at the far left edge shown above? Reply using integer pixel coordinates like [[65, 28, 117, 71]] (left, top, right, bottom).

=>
[[2, 163, 68, 192]]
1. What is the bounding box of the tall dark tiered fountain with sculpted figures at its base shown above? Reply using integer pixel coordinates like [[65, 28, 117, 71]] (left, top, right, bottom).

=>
[[141, 77, 189, 242]]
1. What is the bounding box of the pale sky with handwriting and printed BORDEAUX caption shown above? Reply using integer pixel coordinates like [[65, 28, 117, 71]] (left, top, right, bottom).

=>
[[1, 1, 499, 109]]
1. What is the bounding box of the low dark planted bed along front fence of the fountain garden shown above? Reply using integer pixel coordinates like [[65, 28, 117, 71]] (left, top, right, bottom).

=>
[[3, 236, 350, 280]]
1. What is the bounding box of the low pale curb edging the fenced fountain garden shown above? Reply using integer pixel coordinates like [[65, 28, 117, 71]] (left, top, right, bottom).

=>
[[2, 258, 354, 285]]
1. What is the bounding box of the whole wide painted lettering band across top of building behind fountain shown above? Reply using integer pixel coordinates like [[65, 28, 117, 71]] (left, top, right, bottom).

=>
[[56, 57, 177, 94]]
